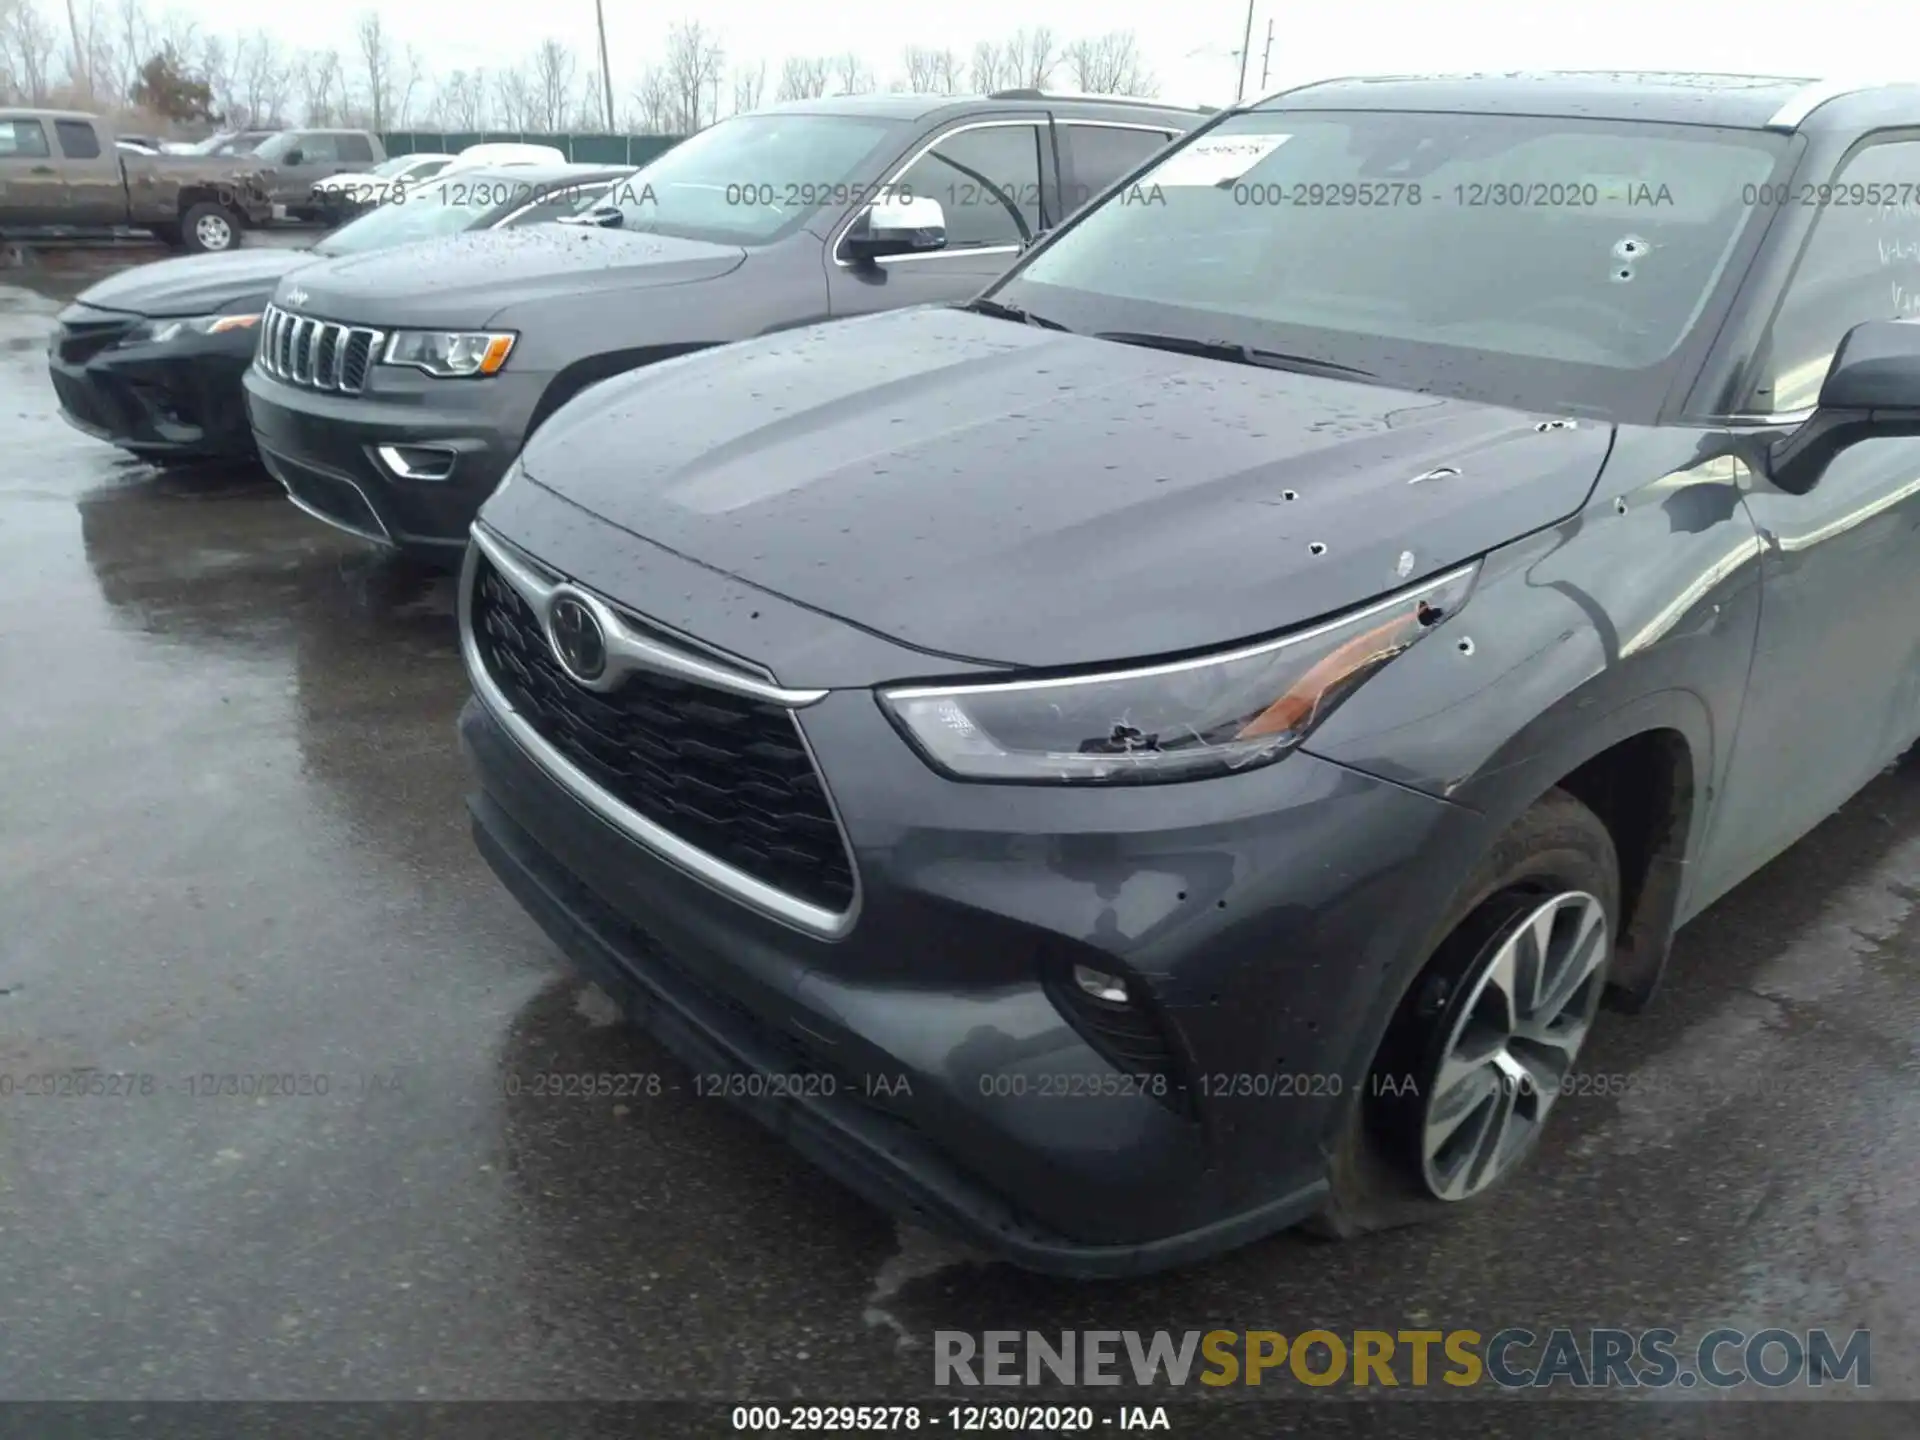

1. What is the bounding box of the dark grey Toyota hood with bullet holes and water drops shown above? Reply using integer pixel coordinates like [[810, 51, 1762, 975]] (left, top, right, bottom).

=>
[[509, 309, 1611, 684]]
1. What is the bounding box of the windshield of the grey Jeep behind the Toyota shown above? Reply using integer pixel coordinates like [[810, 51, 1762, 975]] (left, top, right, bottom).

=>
[[607, 113, 908, 244]]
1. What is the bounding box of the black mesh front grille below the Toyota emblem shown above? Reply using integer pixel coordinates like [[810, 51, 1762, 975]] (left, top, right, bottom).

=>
[[472, 557, 854, 910]]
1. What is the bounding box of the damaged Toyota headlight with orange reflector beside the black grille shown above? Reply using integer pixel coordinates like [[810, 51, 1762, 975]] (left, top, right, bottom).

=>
[[879, 563, 1478, 785]]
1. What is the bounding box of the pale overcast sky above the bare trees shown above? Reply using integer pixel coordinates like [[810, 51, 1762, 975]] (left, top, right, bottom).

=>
[[152, 0, 1889, 104]]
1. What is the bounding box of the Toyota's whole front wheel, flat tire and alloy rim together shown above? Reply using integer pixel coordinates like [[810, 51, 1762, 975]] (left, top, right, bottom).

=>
[[1309, 791, 1620, 1238]]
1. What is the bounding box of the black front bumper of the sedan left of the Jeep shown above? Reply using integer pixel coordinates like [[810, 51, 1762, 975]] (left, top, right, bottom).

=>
[[46, 311, 253, 459]]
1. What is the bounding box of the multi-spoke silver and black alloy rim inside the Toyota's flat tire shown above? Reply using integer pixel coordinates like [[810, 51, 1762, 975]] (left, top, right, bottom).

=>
[[1419, 891, 1613, 1202]]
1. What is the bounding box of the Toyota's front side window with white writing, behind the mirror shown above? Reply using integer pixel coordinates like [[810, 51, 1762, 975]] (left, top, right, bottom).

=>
[[1745, 140, 1920, 415]]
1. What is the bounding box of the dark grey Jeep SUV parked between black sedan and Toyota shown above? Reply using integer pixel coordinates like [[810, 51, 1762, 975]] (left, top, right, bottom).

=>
[[246, 90, 1204, 559]]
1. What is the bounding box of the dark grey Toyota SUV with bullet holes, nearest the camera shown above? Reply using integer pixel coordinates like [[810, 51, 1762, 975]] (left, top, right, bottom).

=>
[[461, 75, 1920, 1275]]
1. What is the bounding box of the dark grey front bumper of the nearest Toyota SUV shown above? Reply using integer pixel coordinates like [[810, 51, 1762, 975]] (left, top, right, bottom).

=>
[[461, 541, 1480, 1275]]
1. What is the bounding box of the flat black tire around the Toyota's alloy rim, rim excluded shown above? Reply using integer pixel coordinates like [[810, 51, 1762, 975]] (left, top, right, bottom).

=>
[[1304, 789, 1620, 1240]]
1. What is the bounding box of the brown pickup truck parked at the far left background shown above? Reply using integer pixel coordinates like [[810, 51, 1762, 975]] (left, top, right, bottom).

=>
[[0, 109, 273, 253]]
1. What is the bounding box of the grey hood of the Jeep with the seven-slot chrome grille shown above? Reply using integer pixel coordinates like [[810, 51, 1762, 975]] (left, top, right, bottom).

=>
[[275, 225, 747, 326]]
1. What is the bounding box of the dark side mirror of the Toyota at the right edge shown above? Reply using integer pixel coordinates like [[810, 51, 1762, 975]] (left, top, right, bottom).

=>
[[1766, 321, 1920, 495]]
